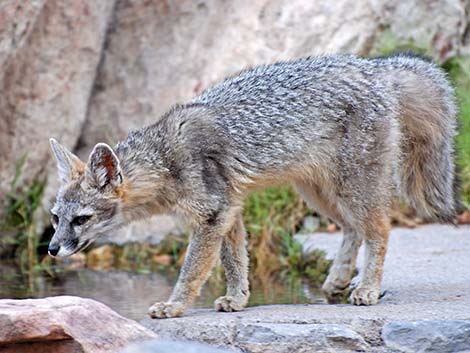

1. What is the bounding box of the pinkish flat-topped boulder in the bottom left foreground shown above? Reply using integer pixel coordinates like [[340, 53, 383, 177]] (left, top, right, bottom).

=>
[[0, 296, 157, 353]]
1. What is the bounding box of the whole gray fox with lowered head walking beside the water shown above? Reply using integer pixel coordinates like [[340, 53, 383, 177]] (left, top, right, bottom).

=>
[[49, 54, 456, 318]]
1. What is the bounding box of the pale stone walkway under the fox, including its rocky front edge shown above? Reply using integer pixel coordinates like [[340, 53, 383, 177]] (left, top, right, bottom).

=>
[[142, 225, 470, 353]]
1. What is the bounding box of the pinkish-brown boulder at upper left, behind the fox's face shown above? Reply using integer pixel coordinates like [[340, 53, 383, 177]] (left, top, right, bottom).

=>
[[0, 0, 114, 220]]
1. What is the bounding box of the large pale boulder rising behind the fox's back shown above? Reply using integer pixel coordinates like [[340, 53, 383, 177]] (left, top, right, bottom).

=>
[[82, 0, 470, 154]]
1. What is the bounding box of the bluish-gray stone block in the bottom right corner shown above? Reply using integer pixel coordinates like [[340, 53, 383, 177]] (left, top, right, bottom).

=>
[[382, 320, 470, 353]]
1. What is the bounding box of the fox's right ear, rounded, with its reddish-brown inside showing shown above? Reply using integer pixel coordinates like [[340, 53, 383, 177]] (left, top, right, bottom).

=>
[[85, 143, 122, 189]]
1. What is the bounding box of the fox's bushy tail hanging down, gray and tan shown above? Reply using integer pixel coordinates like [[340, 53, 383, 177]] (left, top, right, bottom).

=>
[[390, 56, 458, 222]]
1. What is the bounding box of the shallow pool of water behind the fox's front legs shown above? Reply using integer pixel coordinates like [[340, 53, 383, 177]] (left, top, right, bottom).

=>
[[0, 263, 325, 320]]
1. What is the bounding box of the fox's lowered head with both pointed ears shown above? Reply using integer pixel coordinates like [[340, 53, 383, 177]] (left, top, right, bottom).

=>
[[49, 139, 125, 256]]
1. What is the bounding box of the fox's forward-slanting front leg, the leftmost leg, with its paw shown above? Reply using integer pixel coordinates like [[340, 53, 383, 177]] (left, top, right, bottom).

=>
[[149, 221, 223, 319]]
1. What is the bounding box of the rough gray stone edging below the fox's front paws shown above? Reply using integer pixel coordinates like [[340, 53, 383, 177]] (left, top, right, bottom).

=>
[[143, 314, 371, 353]]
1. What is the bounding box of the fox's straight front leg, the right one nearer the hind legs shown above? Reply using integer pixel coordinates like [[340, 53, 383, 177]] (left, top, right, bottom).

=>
[[214, 214, 250, 311]]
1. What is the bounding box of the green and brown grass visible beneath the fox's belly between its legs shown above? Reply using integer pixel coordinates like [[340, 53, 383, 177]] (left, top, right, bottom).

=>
[[244, 186, 331, 284]]
